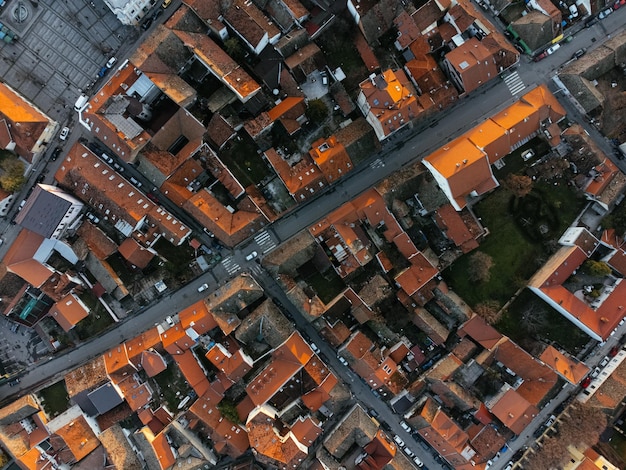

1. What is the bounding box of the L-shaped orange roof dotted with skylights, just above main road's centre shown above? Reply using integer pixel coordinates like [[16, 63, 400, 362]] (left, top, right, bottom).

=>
[[265, 148, 327, 202]]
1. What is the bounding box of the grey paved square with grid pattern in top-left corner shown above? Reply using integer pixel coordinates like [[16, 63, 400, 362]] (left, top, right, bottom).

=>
[[0, 0, 137, 122]]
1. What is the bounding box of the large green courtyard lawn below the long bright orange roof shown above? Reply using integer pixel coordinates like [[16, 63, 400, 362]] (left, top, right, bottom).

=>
[[443, 183, 584, 306]]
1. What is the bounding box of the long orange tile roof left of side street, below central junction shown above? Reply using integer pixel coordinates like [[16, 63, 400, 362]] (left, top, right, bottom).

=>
[[246, 332, 313, 406]]
